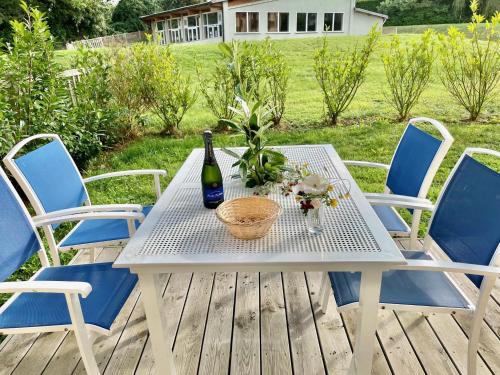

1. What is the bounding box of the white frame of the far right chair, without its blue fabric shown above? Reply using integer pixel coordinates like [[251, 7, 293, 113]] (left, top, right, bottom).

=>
[[344, 117, 454, 248]]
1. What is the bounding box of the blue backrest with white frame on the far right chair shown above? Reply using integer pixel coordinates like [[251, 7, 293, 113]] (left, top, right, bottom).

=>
[[386, 117, 453, 198]]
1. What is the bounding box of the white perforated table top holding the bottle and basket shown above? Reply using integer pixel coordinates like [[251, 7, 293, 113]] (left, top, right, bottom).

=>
[[115, 145, 404, 272]]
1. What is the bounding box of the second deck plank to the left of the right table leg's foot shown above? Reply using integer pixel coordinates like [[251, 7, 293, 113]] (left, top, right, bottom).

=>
[[283, 272, 325, 375]]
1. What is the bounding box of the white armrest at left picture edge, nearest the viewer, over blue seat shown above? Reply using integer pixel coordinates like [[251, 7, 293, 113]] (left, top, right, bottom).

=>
[[0, 280, 92, 298]]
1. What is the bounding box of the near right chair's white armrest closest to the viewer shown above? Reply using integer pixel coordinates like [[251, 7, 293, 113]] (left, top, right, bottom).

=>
[[392, 259, 500, 277]]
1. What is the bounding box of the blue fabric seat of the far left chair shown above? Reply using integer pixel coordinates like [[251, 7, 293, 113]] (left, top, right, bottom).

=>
[[60, 206, 153, 247]]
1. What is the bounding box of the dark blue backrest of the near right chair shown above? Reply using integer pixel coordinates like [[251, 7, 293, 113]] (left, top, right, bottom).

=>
[[429, 149, 500, 287]]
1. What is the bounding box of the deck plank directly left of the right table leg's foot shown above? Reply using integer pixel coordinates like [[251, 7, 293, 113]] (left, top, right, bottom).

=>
[[306, 272, 352, 374]]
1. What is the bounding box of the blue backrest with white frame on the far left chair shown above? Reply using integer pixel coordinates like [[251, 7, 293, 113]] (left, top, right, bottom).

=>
[[4, 134, 88, 215]]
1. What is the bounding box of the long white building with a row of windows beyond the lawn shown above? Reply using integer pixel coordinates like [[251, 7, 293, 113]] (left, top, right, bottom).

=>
[[141, 0, 387, 44]]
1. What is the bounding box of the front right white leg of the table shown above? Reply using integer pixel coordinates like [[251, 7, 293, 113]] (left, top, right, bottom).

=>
[[349, 270, 382, 375]]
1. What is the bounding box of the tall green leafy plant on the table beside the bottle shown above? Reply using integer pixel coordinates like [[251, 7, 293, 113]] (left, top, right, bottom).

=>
[[224, 98, 286, 188]]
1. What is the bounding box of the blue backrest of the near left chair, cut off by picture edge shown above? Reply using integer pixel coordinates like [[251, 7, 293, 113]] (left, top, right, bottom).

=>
[[0, 168, 42, 281]]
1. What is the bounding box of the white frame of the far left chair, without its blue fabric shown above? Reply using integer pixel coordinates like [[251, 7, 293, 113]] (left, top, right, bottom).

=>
[[3, 134, 167, 265]]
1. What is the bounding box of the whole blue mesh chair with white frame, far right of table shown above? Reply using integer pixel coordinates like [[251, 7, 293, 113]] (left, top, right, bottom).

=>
[[344, 117, 453, 247]]
